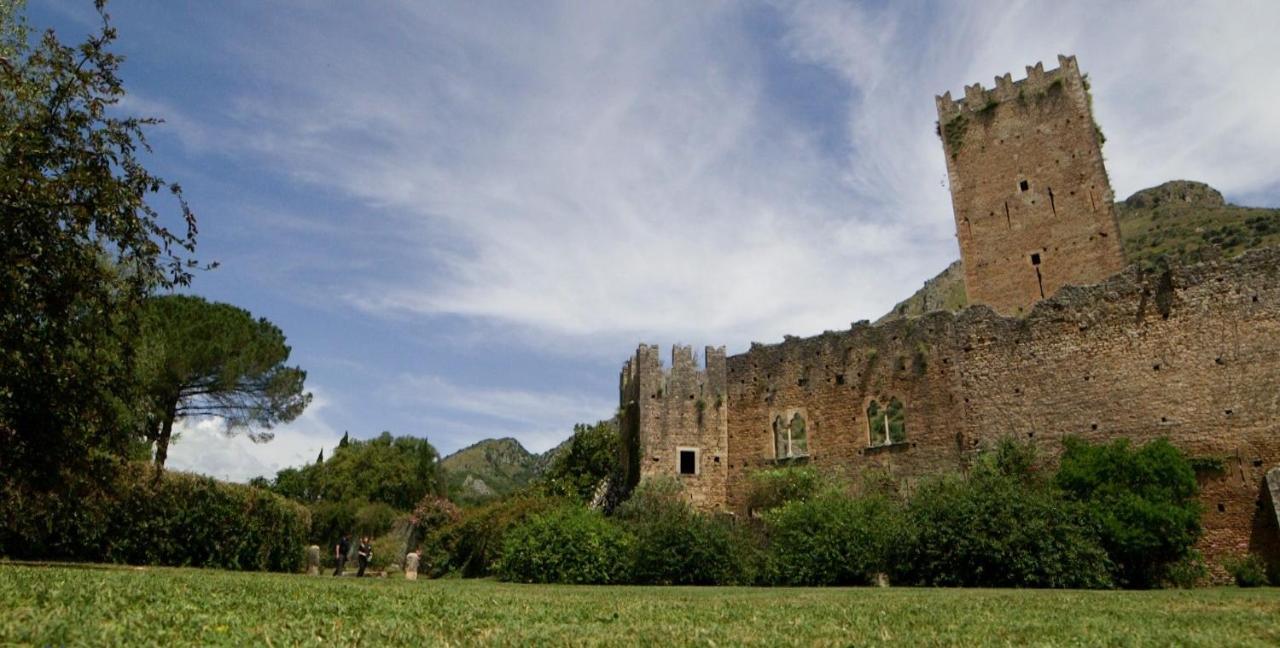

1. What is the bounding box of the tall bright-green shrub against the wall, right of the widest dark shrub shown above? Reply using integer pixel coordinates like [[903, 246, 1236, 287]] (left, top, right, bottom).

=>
[[1055, 438, 1201, 588]]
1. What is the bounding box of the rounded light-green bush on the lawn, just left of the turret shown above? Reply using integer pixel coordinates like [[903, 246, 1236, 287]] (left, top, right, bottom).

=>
[[497, 505, 635, 584]]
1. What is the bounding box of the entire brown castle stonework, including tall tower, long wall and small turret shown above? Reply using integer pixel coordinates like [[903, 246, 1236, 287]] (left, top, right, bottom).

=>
[[620, 58, 1280, 571]]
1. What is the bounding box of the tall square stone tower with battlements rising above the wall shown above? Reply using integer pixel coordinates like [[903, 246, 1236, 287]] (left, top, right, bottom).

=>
[[937, 55, 1125, 315]]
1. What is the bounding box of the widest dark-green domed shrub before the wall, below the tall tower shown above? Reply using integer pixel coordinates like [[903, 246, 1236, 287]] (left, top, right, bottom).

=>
[[893, 470, 1111, 588]]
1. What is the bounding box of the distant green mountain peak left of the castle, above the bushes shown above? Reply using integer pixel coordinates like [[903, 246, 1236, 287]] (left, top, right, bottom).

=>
[[440, 438, 568, 505]]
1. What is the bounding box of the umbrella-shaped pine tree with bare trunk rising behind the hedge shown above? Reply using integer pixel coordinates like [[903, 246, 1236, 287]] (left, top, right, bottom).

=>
[[140, 295, 311, 466]]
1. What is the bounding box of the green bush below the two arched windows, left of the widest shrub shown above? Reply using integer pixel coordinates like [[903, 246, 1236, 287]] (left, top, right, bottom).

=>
[[764, 492, 901, 585]]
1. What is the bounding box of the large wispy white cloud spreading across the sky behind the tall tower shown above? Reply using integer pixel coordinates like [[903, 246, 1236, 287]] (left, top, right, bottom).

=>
[[220, 1, 1280, 348]]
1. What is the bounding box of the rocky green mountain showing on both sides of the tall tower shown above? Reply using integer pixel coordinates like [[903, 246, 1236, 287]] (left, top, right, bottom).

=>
[[876, 181, 1280, 324]]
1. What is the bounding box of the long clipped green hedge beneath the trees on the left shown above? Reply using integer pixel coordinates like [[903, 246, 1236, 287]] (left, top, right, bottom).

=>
[[0, 465, 311, 571]]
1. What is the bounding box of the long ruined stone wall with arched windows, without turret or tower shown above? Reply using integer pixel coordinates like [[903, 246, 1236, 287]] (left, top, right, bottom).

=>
[[711, 248, 1280, 556]]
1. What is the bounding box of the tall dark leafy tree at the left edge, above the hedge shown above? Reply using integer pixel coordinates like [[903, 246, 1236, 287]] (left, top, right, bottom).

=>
[[0, 0, 196, 484]]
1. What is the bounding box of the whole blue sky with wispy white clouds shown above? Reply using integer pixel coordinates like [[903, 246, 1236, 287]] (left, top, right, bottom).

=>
[[28, 0, 1280, 480]]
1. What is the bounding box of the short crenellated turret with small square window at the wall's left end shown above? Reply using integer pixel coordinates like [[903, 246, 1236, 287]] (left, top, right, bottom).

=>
[[620, 344, 728, 510]]
